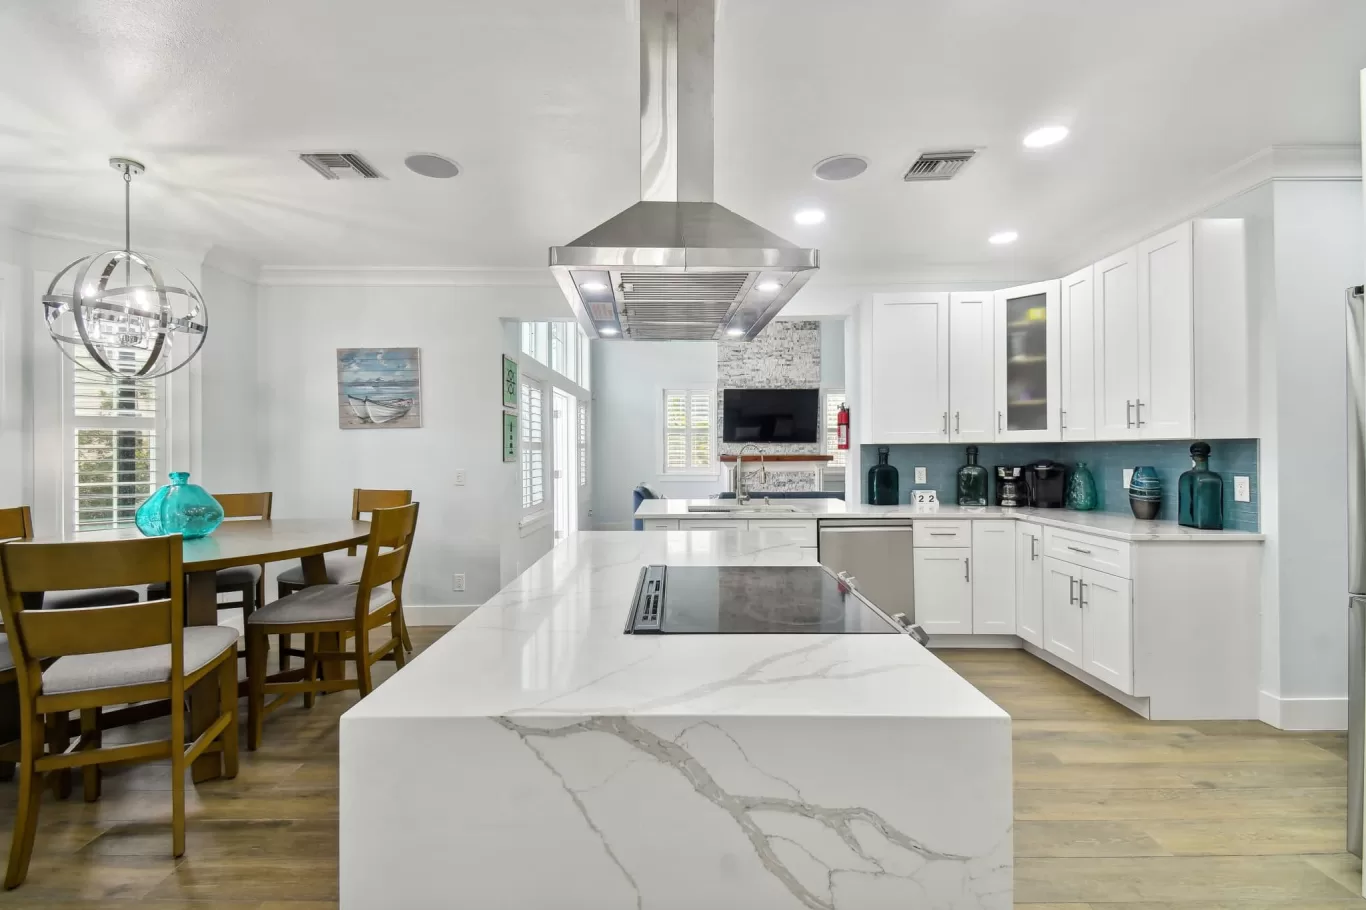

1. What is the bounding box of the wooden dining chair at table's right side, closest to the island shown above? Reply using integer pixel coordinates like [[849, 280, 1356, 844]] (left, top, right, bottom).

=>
[[247, 503, 418, 750]]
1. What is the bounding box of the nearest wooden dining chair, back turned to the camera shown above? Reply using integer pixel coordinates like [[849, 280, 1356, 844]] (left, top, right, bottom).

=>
[[0, 536, 238, 888]]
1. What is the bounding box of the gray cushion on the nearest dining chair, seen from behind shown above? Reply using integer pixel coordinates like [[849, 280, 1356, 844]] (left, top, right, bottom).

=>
[[42, 626, 238, 695]]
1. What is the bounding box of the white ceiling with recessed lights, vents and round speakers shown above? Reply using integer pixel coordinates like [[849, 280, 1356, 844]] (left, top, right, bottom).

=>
[[0, 0, 1366, 273]]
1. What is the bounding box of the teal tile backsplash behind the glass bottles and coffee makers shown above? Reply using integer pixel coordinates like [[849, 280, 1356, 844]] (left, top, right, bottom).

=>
[[861, 439, 1261, 532]]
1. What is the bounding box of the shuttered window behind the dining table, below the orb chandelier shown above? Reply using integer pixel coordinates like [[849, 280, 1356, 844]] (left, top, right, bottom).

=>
[[66, 351, 163, 530]]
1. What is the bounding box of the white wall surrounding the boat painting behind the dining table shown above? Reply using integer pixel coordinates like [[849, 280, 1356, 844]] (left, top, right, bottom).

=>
[[255, 286, 566, 605]]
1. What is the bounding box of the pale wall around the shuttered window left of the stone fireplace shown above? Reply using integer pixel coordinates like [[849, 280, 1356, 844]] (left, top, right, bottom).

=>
[[591, 342, 725, 530]]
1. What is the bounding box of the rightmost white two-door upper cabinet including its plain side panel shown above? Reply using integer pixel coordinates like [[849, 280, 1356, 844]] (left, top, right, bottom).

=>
[[1087, 219, 1255, 439]]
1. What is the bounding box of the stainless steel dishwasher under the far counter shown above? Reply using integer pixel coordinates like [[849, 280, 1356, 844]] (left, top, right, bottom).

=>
[[817, 518, 915, 623]]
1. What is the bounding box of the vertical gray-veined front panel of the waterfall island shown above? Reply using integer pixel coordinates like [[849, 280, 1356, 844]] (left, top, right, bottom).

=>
[[342, 716, 1012, 910]]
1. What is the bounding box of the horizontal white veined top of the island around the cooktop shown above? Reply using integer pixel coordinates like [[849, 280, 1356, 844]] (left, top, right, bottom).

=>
[[347, 530, 1005, 721]]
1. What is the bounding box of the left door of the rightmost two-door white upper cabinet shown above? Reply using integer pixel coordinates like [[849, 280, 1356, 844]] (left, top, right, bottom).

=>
[[1091, 247, 1139, 439]]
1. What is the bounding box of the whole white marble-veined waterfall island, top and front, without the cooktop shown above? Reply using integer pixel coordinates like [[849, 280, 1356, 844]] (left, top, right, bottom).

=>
[[340, 532, 1012, 910]]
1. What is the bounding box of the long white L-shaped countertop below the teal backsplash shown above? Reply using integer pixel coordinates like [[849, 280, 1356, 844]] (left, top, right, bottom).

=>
[[635, 499, 1265, 542]]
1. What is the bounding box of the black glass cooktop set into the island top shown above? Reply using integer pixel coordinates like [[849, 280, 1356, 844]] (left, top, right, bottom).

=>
[[626, 566, 899, 635]]
